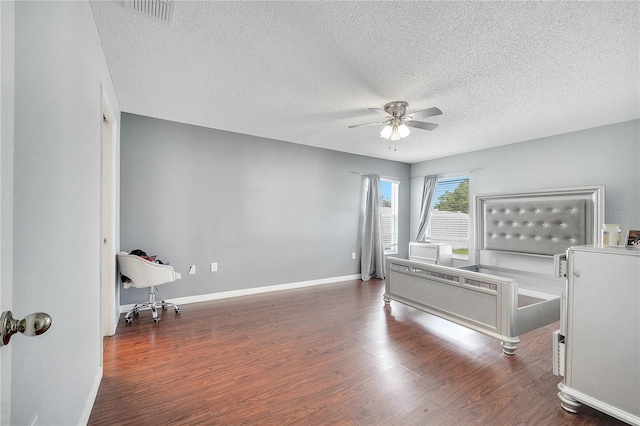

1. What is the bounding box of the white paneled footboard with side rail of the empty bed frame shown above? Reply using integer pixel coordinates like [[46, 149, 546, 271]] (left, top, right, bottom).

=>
[[384, 258, 560, 355]]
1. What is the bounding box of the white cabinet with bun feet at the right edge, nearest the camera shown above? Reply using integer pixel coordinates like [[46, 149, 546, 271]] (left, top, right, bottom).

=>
[[554, 246, 640, 425]]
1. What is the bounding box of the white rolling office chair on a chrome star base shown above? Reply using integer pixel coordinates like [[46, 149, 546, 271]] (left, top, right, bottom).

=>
[[116, 252, 181, 324]]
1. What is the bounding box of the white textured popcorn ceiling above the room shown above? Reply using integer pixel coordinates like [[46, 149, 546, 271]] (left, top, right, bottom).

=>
[[92, 1, 640, 163]]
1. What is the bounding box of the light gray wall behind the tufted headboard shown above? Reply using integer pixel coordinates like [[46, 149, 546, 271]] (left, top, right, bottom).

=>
[[411, 120, 640, 262]]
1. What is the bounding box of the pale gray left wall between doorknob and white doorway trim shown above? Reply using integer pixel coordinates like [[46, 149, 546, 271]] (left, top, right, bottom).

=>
[[10, 2, 120, 425]]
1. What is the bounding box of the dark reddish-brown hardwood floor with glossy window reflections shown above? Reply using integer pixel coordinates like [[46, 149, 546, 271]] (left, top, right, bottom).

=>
[[89, 280, 623, 425]]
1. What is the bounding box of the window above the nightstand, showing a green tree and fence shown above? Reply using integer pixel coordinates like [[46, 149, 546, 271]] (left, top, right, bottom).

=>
[[431, 175, 469, 258]]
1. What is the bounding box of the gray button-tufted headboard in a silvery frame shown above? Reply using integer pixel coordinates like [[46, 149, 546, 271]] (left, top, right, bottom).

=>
[[474, 186, 604, 256]]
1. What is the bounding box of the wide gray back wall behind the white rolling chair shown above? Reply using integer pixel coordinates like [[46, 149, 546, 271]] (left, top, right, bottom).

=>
[[121, 114, 410, 304]]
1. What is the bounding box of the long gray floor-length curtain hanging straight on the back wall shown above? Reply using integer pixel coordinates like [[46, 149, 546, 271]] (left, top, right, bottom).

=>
[[360, 175, 384, 281]]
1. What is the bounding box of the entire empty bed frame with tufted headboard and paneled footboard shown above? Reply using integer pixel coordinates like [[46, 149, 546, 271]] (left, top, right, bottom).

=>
[[383, 185, 604, 355]]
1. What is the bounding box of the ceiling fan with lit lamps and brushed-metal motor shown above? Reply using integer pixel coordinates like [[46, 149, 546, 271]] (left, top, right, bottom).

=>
[[349, 101, 442, 147]]
